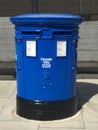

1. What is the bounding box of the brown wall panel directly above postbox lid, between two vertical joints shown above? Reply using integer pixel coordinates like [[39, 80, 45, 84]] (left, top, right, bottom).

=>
[[38, 0, 79, 14]]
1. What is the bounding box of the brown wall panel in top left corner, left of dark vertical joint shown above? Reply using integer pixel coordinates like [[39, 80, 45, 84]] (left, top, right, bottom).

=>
[[0, 0, 32, 16]]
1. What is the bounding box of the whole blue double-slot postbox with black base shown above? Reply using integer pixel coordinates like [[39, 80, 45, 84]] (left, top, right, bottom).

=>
[[11, 14, 83, 120]]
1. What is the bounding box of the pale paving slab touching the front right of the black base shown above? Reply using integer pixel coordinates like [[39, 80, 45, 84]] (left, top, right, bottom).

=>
[[39, 111, 85, 129]]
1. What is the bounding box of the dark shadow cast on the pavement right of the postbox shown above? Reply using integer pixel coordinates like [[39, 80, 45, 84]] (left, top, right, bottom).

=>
[[77, 82, 98, 109]]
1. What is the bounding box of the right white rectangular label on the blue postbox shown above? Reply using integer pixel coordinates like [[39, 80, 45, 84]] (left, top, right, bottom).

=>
[[57, 41, 67, 57]]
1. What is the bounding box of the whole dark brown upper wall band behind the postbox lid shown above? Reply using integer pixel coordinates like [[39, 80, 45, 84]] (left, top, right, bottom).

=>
[[0, 0, 98, 20]]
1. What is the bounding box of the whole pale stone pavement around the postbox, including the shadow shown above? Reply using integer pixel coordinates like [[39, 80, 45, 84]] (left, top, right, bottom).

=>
[[0, 79, 98, 130]]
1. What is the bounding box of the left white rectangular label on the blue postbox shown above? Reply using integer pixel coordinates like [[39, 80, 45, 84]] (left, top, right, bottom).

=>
[[26, 41, 36, 57]]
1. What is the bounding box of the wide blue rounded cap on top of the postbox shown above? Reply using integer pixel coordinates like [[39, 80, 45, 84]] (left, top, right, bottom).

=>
[[11, 14, 84, 24]]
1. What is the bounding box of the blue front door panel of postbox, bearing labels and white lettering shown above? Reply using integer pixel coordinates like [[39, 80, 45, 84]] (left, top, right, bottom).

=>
[[23, 39, 68, 101]]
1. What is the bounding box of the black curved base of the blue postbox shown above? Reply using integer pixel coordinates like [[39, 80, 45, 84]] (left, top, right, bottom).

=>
[[16, 96, 77, 121]]
